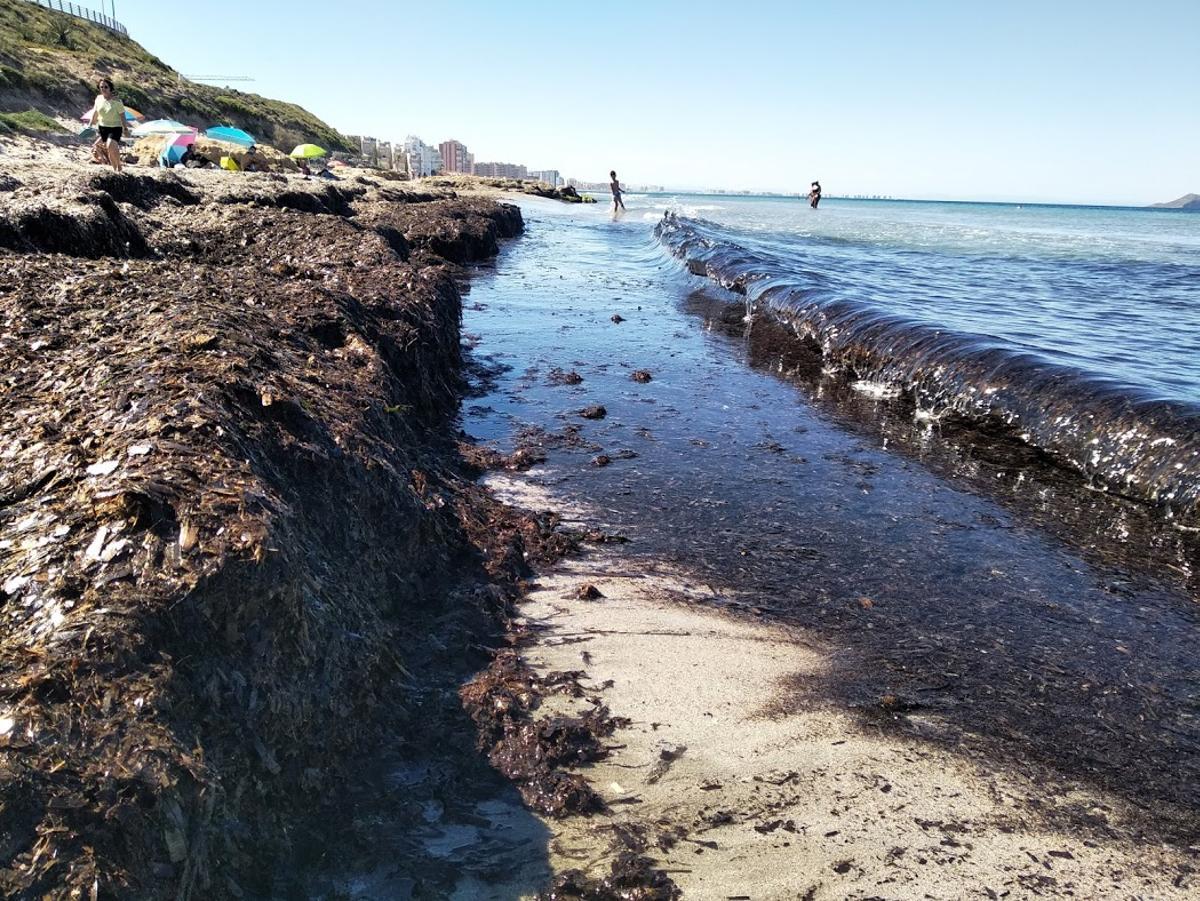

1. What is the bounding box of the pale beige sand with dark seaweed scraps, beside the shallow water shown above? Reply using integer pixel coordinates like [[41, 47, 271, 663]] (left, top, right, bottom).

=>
[[488, 475, 1198, 900]]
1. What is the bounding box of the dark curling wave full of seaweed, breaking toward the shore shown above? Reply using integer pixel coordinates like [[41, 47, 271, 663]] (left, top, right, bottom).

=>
[[655, 214, 1200, 527]]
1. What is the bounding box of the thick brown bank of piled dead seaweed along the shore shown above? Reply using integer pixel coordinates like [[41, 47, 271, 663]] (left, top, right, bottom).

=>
[[0, 167, 522, 899]]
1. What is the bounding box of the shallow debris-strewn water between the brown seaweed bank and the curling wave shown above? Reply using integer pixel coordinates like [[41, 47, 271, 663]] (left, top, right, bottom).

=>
[[463, 196, 1200, 836]]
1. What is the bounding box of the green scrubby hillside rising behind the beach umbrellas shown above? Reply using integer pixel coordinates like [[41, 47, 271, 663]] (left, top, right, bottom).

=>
[[0, 0, 352, 150]]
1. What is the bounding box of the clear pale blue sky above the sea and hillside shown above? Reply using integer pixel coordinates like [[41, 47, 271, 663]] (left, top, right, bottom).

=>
[[108, 0, 1200, 204]]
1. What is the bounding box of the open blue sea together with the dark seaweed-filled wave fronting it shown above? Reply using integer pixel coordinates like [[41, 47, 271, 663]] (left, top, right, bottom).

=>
[[648, 196, 1200, 515]]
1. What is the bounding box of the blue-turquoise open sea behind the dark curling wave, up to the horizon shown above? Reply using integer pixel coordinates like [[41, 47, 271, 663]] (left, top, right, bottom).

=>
[[628, 194, 1200, 402]]
